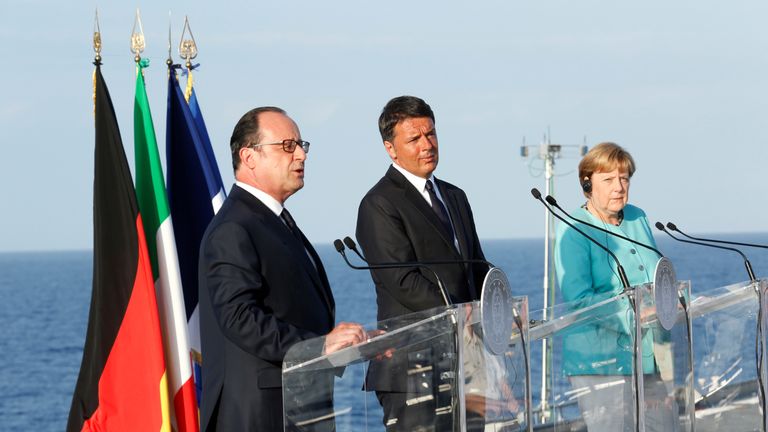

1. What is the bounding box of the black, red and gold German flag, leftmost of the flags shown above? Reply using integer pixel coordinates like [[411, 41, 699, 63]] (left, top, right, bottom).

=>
[[67, 61, 170, 431]]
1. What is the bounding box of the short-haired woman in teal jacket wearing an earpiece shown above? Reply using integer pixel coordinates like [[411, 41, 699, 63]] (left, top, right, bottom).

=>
[[555, 143, 678, 432]]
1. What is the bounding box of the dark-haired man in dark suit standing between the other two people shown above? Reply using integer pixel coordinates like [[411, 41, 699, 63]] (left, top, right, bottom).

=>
[[356, 96, 488, 430]]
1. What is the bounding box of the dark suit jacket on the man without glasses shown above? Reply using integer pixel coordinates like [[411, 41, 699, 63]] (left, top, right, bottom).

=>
[[356, 167, 488, 391]]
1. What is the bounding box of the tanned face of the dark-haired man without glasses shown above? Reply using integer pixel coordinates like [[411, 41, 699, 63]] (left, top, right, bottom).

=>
[[384, 117, 438, 178]]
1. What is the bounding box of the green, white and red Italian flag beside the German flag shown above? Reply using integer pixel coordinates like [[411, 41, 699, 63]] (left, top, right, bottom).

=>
[[133, 59, 199, 432]]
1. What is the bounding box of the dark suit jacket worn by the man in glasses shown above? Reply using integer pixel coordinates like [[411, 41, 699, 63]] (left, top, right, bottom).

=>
[[199, 186, 334, 431]]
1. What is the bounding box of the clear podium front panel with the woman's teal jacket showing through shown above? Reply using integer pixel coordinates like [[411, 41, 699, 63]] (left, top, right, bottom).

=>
[[530, 294, 637, 431]]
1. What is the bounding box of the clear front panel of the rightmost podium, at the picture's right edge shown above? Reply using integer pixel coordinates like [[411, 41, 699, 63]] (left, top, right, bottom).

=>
[[691, 280, 768, 431]]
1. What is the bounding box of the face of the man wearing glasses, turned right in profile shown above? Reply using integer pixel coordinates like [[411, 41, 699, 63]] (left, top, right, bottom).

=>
[[240, 112, 307, 203]]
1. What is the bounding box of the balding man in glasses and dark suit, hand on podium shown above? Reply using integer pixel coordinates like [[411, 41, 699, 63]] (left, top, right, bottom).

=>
[[199, 107, 366, 431]]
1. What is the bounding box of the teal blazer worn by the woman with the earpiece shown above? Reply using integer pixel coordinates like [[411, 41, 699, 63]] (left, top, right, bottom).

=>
[[555, 204, 660, 375]]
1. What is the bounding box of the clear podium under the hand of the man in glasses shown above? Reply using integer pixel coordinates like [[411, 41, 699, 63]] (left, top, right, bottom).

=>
[[283, 298, 530, 431]]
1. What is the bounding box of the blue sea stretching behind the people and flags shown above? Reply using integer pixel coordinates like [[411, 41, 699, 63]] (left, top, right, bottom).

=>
[[0, 233, 768, 431]]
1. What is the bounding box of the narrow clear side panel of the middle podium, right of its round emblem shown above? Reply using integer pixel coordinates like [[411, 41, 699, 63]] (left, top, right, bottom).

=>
[[635, 282, 695, 432]]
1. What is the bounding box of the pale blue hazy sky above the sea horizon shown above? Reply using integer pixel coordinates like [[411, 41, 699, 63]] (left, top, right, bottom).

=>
[[0, 0, 768, 251]]
